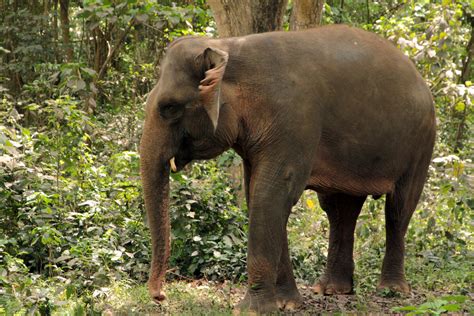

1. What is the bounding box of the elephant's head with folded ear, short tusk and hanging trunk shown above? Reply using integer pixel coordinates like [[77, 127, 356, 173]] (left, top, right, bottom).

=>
[[140, 38, 237, 300]]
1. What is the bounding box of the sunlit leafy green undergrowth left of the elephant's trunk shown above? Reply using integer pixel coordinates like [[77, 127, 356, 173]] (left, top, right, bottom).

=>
[[0, 98, 149, 314]]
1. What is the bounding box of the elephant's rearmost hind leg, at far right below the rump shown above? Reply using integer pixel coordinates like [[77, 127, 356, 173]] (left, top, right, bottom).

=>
[[378, 160, 429, 293]]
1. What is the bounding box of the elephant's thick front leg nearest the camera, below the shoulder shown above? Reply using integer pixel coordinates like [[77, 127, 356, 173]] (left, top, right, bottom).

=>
[[236, 165, 306, 313]]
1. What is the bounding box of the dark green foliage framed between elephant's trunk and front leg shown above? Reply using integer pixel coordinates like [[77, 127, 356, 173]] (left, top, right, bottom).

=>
[[171, 161, 247, 280]]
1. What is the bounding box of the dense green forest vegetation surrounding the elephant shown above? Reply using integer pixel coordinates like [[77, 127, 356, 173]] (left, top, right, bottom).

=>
[[0, 0, 474, 315]]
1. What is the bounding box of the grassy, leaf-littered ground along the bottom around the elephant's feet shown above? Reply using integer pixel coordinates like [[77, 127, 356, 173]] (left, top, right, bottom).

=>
[[0, 252, 474, 316]]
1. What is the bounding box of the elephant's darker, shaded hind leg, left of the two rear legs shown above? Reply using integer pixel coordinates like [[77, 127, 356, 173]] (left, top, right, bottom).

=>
[[313, 193, 366, 295]]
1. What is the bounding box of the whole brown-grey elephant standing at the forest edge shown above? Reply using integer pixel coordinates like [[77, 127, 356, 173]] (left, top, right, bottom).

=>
[[140, 25, 436, 313]]
